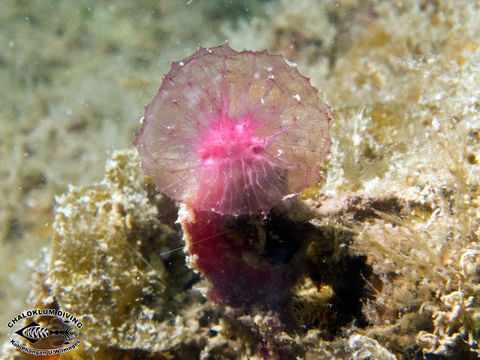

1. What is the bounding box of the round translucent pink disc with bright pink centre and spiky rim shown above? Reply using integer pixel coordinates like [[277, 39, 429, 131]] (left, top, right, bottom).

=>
[[134, 44, 333, 215]]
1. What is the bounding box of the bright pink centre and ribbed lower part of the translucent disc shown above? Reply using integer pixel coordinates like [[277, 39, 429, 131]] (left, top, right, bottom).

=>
[[192, 116, 286, 214]]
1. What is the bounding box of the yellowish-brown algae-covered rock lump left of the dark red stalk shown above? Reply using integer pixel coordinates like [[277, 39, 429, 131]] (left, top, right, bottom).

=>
[[48, 151, 208, 353]]
